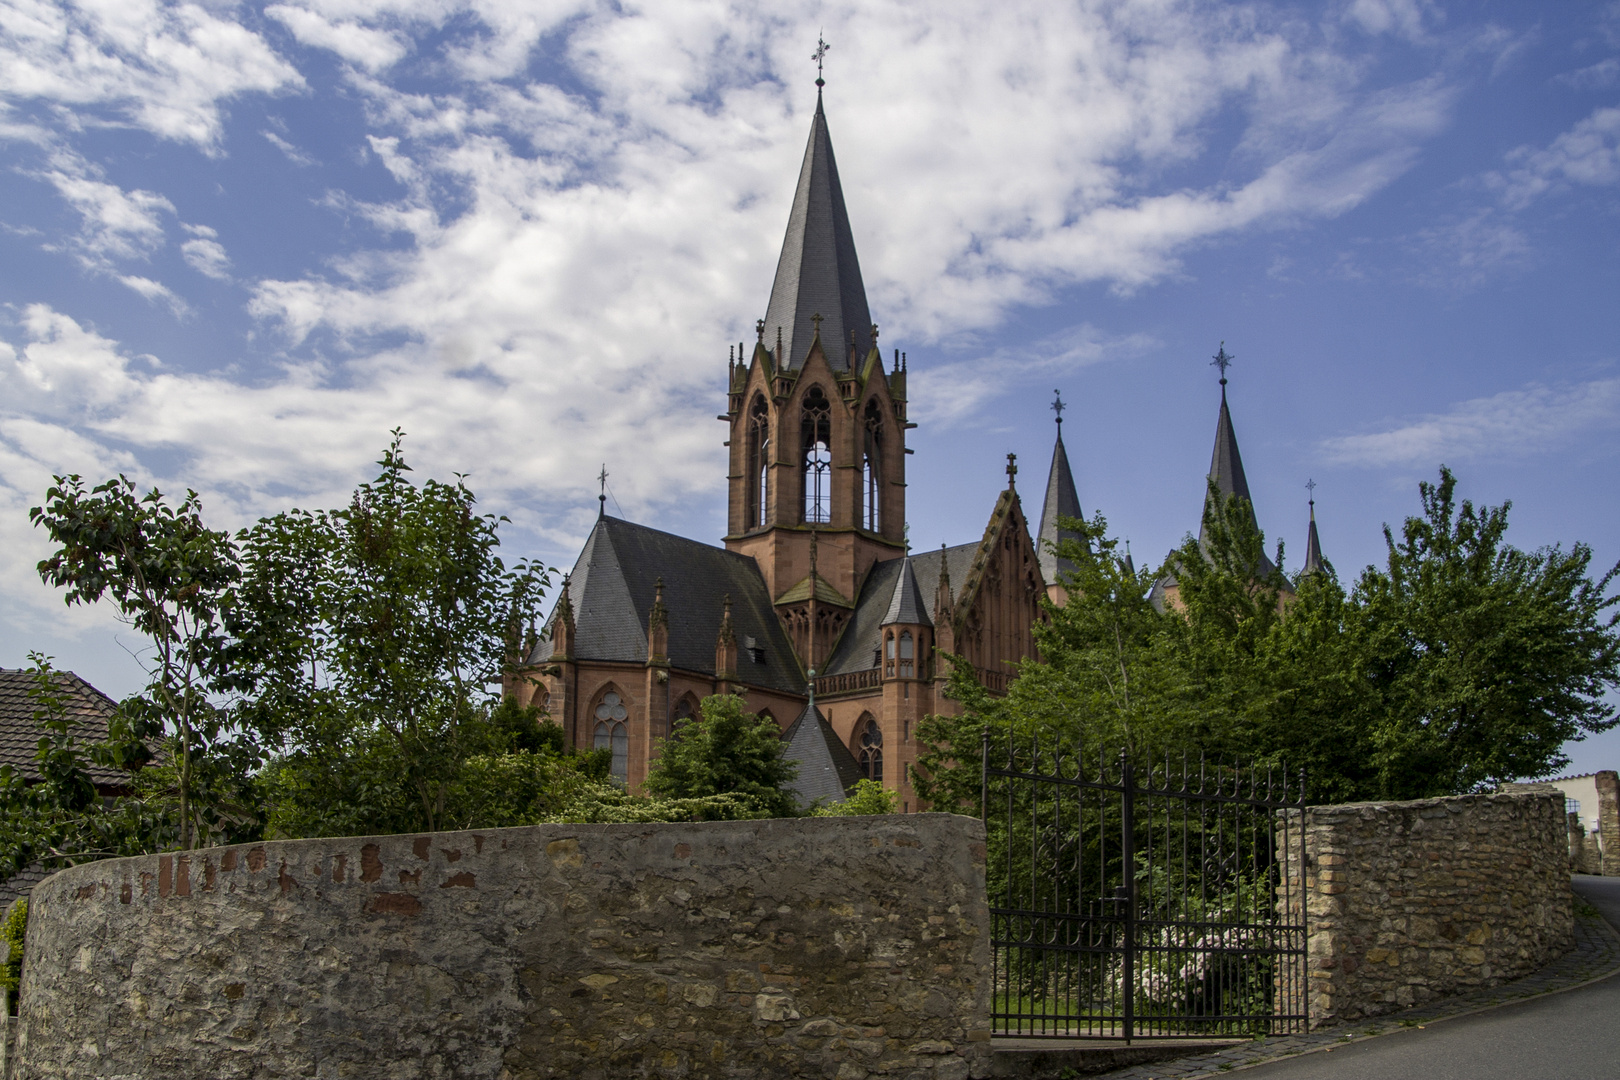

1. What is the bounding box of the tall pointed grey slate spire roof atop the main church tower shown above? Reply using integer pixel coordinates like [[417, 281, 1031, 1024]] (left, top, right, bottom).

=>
[[765, 94, 873, 371]]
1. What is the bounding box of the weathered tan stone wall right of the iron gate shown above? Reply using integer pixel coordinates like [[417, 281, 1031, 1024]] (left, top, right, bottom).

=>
[[1285, 792, 1575, 1027]]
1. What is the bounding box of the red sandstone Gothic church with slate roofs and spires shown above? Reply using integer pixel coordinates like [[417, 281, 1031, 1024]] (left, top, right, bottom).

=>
[[507, 79, 1314, 813]]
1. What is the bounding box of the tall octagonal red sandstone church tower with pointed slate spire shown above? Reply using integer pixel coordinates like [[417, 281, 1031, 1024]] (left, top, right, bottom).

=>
[[721, 89, 914, 667]]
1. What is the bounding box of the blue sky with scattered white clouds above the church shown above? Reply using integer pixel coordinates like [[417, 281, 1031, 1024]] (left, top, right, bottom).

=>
[[0, 0, 1620, 771]]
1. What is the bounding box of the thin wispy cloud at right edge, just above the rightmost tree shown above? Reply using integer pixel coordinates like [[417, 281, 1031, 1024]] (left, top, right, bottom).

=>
[[1322, 379, 1620, 466]]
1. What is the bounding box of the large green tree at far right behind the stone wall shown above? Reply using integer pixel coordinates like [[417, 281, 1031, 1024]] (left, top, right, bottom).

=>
[[1354, 466, 1620, 798]]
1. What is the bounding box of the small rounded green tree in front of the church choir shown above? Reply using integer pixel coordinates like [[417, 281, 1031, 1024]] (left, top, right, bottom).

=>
[[643, 695, 799, 818]]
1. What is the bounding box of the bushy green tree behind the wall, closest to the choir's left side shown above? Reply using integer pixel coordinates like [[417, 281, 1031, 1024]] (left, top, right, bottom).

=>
[[232, 431, 549, 832]]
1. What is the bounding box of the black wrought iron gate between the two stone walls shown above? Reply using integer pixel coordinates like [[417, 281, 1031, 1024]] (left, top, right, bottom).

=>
[[980, 733, 1306, 1040]]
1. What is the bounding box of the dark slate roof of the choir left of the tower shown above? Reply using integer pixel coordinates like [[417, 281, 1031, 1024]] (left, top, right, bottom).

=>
[[530, 517, 805, 695]]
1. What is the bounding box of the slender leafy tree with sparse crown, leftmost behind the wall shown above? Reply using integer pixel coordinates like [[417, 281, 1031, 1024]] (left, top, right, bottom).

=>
[[29, 476, 259, 847]]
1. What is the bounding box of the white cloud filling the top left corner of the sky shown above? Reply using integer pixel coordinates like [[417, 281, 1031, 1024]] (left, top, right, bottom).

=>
[[0, 0, 303, 149]]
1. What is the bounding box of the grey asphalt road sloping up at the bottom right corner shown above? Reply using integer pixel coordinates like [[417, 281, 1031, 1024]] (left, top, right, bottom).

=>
[[1243, 876, 1620, 1080]]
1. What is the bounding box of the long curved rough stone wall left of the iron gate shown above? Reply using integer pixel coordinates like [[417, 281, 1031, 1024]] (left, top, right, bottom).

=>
[[15, 814, 990, 1080]]
